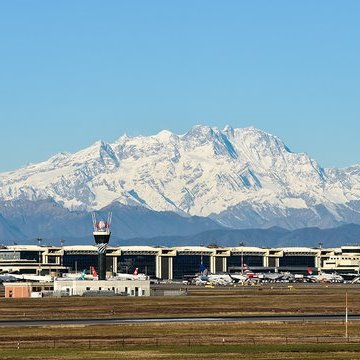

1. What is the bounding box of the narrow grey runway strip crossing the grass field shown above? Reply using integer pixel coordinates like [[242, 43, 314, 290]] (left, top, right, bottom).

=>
[[0, 314, 360, 327]]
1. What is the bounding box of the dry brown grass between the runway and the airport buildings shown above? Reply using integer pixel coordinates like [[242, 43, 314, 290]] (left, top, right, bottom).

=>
[[0, 285, 360, 319]]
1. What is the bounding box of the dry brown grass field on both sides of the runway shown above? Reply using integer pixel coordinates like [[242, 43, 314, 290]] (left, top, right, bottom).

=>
[[0, 285, 360, 360]]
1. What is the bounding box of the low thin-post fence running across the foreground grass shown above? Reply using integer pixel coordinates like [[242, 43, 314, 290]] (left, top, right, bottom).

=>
[[0, 335, 360, 349]]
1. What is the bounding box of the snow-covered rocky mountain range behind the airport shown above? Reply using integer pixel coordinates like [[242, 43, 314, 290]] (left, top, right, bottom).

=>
[[0, 126, 360, 228]]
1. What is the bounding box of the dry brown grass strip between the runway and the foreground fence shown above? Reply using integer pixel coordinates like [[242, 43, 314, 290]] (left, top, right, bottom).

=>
[[0, 322, 360, 347]]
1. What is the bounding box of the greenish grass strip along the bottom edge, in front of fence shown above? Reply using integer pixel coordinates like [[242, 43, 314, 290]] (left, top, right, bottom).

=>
[[0, 344, 360, 360]]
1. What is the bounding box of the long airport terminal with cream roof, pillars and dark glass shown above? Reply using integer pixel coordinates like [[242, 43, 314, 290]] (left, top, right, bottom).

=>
[[0, 245, 360, 280]]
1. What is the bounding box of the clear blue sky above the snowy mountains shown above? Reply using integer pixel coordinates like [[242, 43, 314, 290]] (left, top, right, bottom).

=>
[[0, 0, 360, 171]]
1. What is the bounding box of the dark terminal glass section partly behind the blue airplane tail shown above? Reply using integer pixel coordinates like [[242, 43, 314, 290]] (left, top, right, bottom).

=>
[[173, 255, 210, 279]]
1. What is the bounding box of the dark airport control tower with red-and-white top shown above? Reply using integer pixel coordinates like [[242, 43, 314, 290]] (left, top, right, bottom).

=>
[[92, 212, 112, 280]]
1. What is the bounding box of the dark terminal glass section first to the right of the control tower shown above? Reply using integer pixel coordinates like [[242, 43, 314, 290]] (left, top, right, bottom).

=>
[[118, 255, 156, 276]]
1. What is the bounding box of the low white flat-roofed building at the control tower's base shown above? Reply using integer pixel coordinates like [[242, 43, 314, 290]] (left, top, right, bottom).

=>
[[54, 279, 150, 296]]
